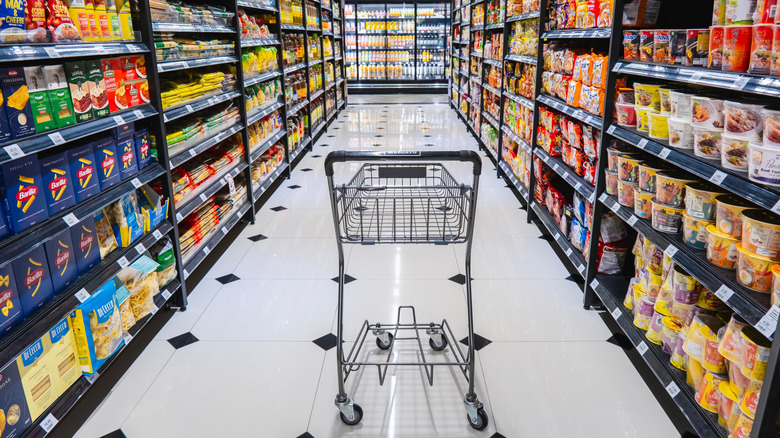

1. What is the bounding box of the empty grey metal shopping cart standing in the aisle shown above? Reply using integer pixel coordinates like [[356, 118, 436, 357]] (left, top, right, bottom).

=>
[[325, 151, 488, 430]]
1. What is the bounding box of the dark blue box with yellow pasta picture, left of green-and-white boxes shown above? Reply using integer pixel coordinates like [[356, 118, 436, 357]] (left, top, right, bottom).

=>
[[0, 67, 35, 139]]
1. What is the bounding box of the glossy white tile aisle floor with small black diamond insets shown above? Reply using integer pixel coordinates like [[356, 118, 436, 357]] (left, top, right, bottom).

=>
[[77, 95, 678, 438]]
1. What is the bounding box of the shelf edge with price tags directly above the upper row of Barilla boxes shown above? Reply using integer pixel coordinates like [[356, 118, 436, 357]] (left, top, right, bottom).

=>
[[0, 104, 157, 163]]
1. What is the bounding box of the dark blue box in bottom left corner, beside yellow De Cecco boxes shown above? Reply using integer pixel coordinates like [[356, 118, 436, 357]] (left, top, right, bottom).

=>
[[0, 362, 32, 438]]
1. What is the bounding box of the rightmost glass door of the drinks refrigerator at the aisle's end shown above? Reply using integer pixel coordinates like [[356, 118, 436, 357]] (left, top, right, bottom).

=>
[[416, 3, 449, 80]]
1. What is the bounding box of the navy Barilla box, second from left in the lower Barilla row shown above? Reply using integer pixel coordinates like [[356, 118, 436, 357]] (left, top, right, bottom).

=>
[[13, 245, 54, 317]]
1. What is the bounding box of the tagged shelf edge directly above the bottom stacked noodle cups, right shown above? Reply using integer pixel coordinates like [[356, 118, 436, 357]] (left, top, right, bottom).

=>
[[599, 193, 772, 339]]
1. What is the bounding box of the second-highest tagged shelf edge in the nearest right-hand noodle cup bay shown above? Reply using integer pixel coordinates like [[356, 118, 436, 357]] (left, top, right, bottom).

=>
[[607, 124, 780, 213]]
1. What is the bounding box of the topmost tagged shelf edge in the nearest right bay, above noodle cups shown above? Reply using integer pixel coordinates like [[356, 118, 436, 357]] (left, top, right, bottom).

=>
[[612, 60, 780, 97]]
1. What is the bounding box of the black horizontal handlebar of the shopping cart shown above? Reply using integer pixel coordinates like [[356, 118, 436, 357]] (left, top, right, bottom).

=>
[[325, 150, 482, 177]]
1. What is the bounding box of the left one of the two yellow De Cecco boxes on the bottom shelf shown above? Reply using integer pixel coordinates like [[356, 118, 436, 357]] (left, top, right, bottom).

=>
[[16, 335, 59, 421]]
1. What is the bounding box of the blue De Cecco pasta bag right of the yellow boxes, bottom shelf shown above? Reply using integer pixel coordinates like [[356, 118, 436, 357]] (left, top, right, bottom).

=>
[[68, 279, 124, 374]]
